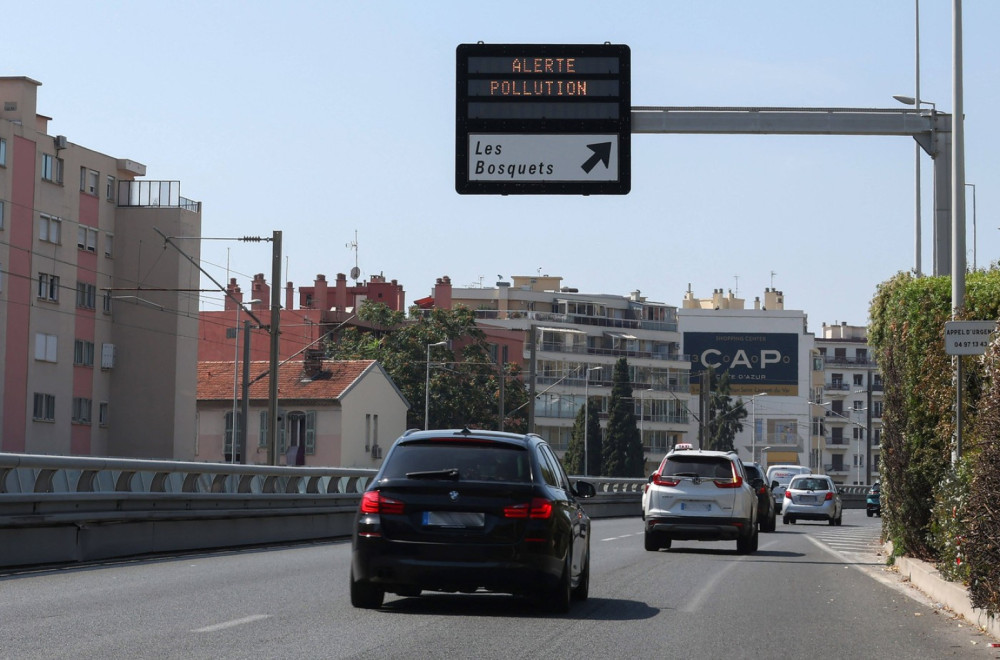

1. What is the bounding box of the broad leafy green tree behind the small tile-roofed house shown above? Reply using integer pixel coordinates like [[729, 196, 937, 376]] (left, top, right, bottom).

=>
[[328, 301, 528, 432]]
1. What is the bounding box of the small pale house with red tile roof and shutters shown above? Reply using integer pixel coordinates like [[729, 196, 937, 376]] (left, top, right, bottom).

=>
[[195, 359, 409, 468]]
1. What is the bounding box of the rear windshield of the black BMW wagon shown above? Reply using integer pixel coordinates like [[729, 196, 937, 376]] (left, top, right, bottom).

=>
[[382, 442, 531, 482]]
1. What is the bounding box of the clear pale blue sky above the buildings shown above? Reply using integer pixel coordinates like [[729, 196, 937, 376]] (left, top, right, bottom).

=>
[[9, 0, 1000, 332]]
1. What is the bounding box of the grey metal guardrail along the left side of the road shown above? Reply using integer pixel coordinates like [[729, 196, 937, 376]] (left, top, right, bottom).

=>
[[0, 453, 646, 566]]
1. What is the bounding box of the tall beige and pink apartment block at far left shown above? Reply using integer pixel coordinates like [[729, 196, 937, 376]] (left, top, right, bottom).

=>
[[0, 77, 201, 458]]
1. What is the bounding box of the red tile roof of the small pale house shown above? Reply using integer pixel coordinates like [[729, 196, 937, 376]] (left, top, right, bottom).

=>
[[198, 360, 375, 401]]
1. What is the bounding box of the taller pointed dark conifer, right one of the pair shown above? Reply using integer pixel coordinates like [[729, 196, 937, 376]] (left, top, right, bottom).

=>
[[602, 357, 646, 477]]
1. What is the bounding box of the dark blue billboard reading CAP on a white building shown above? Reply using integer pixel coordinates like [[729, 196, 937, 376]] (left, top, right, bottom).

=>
[[684, 332, 799, 396]]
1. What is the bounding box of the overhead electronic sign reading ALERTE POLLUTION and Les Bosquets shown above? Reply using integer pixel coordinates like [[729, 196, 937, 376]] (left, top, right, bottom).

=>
[[455, 44, 632, 195]]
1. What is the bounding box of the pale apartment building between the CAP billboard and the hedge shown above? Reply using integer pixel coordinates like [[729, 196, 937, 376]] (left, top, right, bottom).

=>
[[815, 323, 883, 484]]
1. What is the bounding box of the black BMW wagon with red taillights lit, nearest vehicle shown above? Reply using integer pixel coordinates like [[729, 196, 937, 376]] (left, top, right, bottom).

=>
[[350, 429, 595, 612]]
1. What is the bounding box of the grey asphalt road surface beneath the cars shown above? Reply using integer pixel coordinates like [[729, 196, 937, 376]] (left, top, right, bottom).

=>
[[0, 510, 1000, 660]]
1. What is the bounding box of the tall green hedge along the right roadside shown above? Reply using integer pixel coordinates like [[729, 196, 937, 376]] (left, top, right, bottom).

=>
[[868, 264, 1000, 613]]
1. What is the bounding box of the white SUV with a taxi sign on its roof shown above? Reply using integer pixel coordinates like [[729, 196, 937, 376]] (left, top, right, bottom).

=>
[[643, 449, 757, 554]]
